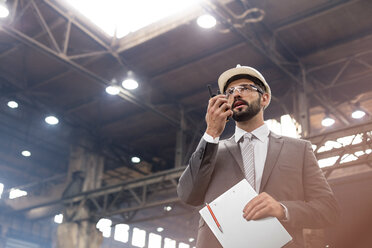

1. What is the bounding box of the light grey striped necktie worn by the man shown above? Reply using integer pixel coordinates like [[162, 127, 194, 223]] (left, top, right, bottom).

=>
[[240, 133, 256, 189]]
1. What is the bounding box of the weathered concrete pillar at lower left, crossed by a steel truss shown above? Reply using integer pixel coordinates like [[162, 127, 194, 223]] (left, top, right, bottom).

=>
[[57, 139, 104, 248]]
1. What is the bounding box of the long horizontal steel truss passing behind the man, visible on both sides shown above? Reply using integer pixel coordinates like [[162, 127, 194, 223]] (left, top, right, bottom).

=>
[[5, 122, 372, 222]]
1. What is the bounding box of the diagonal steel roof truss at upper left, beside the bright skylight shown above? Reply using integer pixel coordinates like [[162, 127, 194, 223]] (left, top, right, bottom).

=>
[[0, 0, 192, 176]]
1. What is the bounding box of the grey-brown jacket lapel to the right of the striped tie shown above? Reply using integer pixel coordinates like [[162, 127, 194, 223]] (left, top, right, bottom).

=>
[[260, 132, 283, 193]]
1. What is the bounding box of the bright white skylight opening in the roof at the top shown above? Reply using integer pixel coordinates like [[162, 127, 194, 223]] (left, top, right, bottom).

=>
[[64, 0, 200, 38]]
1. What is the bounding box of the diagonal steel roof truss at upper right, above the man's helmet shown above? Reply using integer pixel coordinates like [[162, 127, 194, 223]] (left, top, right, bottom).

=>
[[204, 0, 372, 132]]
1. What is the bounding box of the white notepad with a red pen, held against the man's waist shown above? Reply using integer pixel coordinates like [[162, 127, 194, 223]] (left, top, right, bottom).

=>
[[199, 179, 292, 248]]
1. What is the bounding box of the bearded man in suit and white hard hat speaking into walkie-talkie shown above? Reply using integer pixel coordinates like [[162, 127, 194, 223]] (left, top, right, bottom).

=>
[[177, 65, 339, 248]]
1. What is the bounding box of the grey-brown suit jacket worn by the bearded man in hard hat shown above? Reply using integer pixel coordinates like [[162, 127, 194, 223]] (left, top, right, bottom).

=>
[[177, 133, 339, 248]]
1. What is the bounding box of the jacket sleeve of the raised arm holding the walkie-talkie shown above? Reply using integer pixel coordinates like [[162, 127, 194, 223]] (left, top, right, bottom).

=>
[[177, 138, 218, 206]]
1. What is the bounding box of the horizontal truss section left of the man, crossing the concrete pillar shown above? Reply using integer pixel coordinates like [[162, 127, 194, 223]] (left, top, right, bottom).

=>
[[11, 167, 185, 222]]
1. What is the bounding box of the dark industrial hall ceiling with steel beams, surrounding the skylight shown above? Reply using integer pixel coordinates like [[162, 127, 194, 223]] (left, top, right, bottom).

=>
[[0, 0, 372, 244]]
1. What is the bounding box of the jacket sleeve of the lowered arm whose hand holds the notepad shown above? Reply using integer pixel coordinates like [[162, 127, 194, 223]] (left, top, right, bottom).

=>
[[281, 142, 340, 228]]
